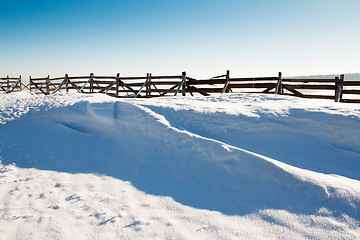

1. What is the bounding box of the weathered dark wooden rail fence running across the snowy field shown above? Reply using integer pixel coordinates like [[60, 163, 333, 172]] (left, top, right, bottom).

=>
[[3, 71, 360, 103]]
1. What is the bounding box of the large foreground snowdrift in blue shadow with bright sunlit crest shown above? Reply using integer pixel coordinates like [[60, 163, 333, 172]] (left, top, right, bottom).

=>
[[0, 101, 360, 219]]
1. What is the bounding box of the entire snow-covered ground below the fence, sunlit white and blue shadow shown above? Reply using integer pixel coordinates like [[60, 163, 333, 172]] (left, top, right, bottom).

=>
[[0, 93, 360, 239]]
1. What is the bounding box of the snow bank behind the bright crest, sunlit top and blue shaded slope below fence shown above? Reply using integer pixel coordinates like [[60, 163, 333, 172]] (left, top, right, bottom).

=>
[[131, 94, 360, 180]]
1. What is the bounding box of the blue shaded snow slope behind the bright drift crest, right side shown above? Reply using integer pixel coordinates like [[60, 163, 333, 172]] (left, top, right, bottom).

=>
[[141, 105, 360, 180]]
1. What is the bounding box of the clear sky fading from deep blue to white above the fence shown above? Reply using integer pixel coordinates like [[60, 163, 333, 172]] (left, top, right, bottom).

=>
[[0, 0, 360, 77]]
